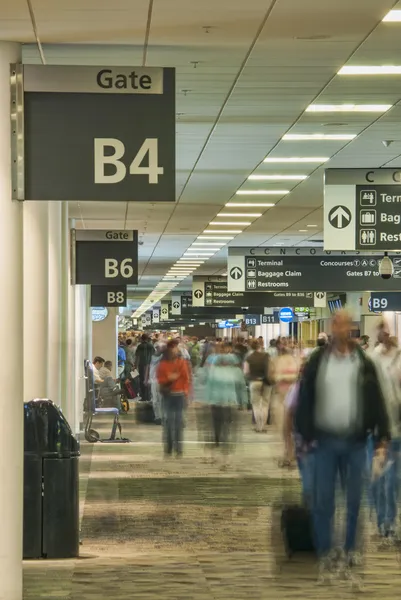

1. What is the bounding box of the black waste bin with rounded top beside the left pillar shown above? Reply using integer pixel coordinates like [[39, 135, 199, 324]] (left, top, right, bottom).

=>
[[24, 399, 80, 559]]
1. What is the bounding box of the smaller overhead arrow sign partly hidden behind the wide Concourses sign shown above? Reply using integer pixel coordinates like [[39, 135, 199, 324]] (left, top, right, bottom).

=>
[[192, 274, 314, 308]]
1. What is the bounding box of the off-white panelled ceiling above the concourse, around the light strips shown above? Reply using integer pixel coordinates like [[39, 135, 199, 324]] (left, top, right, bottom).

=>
[[0, 0, 401, 300]]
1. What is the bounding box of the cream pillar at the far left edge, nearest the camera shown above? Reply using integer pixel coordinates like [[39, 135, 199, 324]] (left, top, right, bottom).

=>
[[0, 42, 22, 600]]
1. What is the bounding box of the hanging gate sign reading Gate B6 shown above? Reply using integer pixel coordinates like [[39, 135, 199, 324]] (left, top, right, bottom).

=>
[[71, 229, 138, 286]]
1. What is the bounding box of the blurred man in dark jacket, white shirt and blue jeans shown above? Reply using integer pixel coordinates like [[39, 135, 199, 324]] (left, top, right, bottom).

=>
[[296, 311, 389, 580]]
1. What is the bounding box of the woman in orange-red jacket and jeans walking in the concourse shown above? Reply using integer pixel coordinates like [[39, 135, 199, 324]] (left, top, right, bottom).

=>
[[157, 340, 190, 457]]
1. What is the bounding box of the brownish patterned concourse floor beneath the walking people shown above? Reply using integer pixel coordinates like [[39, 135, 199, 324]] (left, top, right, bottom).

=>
[[24, 410, 401, 600]]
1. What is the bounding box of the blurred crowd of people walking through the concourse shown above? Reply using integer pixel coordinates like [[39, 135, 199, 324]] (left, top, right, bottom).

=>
[[99, 311, 401, 579]]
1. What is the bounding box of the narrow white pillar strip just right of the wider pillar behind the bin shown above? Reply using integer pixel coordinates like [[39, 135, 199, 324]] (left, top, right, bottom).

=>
[[47, 202, 63, 408]]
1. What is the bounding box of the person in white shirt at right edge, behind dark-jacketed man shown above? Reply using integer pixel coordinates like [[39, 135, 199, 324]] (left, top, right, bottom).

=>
[[370, 323, 401, 541]]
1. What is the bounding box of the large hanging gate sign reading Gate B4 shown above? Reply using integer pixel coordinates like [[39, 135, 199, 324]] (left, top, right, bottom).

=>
[[11, 65, 175, 202]]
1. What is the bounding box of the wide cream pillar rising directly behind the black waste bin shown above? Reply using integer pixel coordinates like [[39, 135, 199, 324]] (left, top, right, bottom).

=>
[[20, 202, 49, 401]]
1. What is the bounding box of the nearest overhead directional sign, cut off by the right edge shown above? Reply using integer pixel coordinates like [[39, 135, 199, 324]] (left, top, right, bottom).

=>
[[324, 169, 401, 251]]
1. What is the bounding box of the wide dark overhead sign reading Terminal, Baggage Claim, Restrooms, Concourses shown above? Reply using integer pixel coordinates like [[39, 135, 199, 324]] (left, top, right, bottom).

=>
[[228, 247, 401, 294]]
